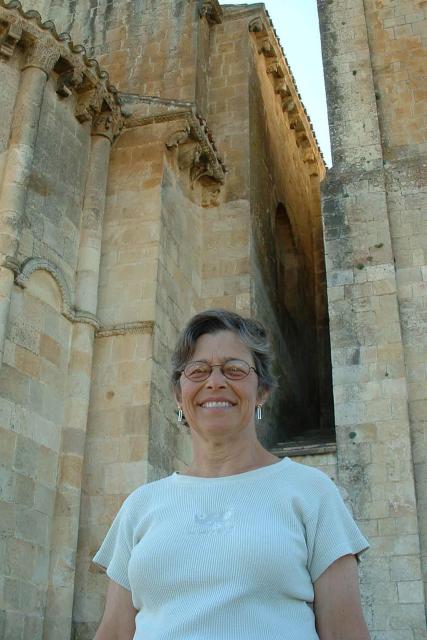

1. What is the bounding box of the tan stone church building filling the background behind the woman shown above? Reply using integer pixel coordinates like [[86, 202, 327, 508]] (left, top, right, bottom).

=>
[[0, 0, 427, 640]]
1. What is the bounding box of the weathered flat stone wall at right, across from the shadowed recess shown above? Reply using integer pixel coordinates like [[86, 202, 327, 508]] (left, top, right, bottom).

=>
[[319, 0, 426, 639]]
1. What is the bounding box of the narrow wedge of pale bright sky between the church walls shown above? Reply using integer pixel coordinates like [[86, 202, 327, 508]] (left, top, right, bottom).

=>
[[226, 0, 332, 166]]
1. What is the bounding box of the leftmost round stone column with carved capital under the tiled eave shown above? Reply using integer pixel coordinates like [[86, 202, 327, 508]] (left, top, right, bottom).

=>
[[0, 40, 59, 366]]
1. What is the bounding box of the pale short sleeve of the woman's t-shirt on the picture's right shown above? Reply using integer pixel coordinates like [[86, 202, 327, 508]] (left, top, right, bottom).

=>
[[306, 481, 369, 582]]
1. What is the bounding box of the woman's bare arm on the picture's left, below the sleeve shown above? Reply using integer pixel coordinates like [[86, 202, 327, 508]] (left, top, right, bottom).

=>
[[94, 581, 137, 640]]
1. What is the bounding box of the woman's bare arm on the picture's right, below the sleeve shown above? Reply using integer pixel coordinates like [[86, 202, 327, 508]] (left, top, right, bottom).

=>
[[314, 555, 369, 640]]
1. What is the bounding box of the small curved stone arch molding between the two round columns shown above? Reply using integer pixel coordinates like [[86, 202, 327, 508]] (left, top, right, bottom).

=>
[[15, 258, 72, 317]]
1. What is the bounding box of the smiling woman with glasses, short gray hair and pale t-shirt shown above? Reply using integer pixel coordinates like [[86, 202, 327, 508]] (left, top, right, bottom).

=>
[[94, 310, 369, 640]]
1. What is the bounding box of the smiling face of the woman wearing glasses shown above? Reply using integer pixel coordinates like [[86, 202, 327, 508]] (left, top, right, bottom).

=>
[[177, 331, 265, 437]]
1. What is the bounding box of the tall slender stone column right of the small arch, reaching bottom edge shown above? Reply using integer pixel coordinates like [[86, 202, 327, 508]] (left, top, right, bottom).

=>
[[43, 115, 112, 640]]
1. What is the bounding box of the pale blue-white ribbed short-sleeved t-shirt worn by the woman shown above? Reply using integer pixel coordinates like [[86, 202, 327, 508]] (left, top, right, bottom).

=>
[[94, 458, 368, 640]]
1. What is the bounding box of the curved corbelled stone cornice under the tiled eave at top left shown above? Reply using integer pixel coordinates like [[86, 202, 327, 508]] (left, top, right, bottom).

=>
[[0, 0, 123, 140]]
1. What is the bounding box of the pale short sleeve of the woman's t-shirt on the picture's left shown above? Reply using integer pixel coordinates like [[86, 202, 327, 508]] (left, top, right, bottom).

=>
[[93, 500, 133, 591]]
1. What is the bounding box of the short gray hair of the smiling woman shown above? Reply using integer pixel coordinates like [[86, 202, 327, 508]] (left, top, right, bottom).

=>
[[171, 309, 276, 391]]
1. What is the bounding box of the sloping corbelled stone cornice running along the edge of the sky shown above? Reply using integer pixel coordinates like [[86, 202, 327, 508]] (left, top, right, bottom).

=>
[[248, 11, 326, 178]]
